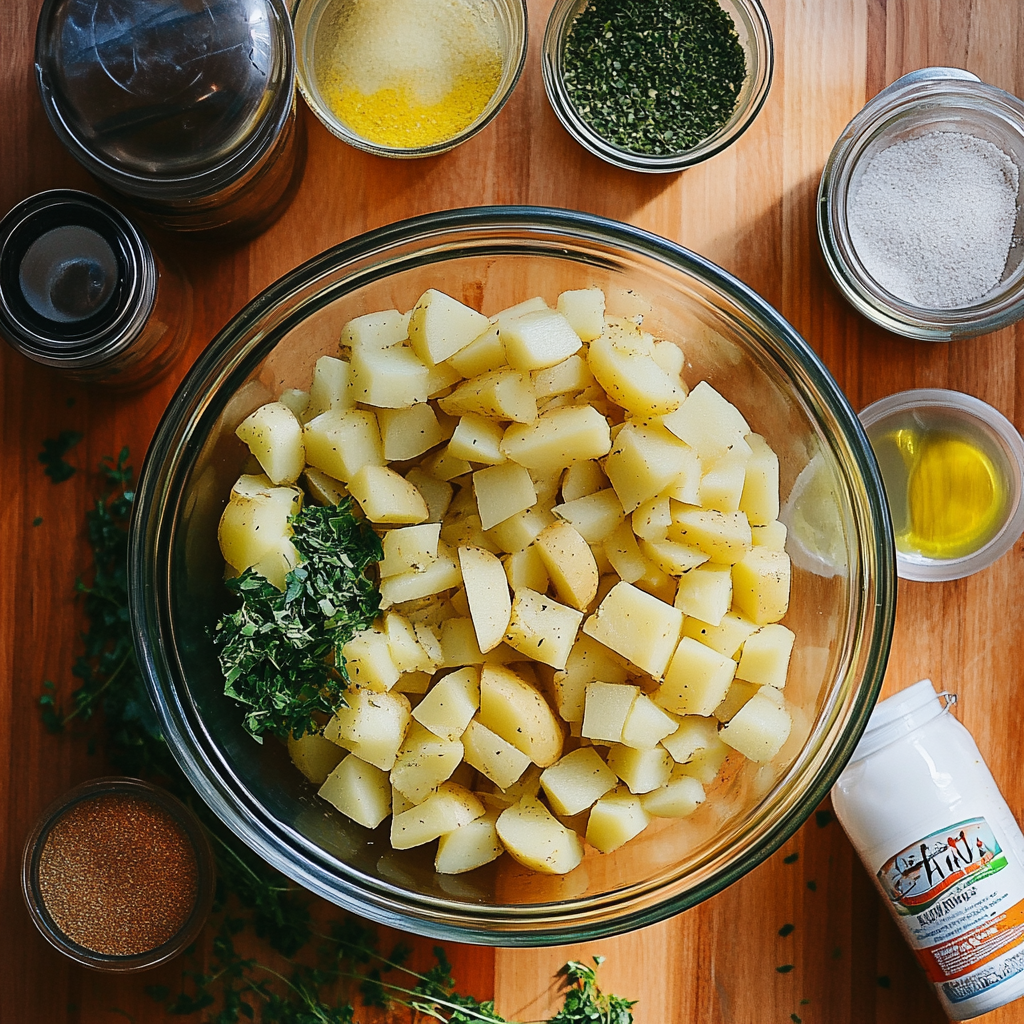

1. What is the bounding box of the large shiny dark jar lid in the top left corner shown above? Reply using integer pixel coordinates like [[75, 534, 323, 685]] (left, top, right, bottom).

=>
[[36, 0, 295, 200]]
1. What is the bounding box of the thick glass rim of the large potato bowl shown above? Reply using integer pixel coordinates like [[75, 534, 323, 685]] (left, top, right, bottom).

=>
[[128, 206, 895, 946]]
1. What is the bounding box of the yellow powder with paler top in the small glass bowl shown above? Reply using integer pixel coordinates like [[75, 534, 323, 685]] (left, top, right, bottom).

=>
[[314, 0, 502, 148]]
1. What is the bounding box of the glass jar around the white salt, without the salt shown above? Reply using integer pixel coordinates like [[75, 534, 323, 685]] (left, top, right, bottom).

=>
[[818, 68, 1024, 341]]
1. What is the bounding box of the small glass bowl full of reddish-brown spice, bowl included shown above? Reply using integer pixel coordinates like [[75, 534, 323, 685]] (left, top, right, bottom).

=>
[[22, 778, 214, 973]]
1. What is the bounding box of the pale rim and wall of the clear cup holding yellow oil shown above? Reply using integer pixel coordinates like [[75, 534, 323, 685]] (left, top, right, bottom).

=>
[[859, 388, 1024, 583]]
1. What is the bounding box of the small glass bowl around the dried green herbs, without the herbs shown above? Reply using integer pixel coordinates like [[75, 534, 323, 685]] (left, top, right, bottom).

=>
[[542, 0, 775, 174]]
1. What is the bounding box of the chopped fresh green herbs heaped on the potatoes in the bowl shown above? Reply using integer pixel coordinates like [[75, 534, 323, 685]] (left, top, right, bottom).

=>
[[213, 498, 384, 742]]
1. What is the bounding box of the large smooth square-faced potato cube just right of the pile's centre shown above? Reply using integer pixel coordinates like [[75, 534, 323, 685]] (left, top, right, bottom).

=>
[[583, 583, 683, 679]]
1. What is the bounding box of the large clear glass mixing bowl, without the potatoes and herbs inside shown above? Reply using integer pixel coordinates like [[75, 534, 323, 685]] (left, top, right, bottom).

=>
[[129, 207, 895, 945]]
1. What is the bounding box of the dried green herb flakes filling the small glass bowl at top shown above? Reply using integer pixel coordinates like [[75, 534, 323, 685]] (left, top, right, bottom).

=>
[[562, 0, 746, 156]]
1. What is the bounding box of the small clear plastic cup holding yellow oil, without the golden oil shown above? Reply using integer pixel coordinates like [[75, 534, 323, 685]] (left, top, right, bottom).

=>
[[860, 388, 1024, 582]]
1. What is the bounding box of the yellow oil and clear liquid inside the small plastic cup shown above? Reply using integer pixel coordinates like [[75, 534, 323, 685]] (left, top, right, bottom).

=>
[[868, 413, 1010, 559]]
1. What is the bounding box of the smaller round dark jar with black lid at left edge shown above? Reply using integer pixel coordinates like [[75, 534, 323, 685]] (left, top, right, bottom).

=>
[[0, 188, 158, 370]]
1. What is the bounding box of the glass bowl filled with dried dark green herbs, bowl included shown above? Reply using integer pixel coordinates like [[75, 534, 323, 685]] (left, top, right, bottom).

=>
[[542, 0, 774, 174]]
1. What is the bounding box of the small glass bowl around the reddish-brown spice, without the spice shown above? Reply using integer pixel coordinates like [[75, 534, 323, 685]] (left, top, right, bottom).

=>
[[22, 776, 216, 974]]
